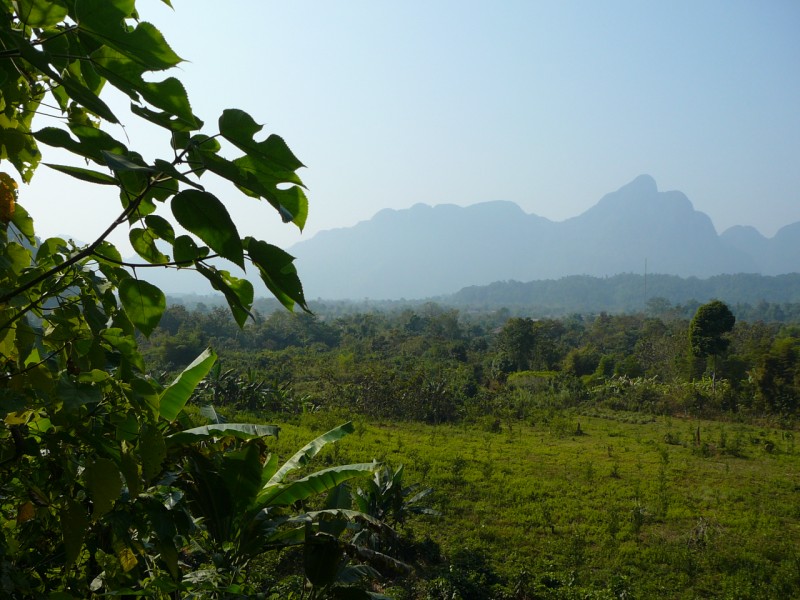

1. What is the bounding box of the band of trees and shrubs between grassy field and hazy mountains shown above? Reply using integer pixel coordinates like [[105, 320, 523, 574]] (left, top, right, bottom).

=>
[[143, 301, 800, 423]]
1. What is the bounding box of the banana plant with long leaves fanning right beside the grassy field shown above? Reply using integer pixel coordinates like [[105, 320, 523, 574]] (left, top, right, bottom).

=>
[[166, 423, 381, 590]]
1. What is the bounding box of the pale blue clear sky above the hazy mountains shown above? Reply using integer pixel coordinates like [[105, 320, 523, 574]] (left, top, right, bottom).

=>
[[20, 0, 800, 250]]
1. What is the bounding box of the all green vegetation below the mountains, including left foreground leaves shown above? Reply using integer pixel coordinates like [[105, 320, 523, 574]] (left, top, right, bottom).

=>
[[0, 0, 800, 599]]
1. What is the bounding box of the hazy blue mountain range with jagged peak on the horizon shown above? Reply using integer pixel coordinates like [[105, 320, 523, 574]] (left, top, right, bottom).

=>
[[289, 175, 800, 299]]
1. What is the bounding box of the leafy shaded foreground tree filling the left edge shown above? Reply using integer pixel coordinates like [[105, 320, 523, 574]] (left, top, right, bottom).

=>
[[0, 0, 390, 598]]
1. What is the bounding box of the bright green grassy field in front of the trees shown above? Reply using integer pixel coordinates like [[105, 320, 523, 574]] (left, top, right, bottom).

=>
[[264, 413, 800, 598]]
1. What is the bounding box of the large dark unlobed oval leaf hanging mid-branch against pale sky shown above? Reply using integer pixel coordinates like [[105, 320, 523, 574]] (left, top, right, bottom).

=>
[[171, 190, 244, 269]]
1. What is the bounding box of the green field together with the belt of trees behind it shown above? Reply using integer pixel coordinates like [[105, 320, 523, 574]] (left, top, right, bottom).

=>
[[133, 304, 800, 598]]
